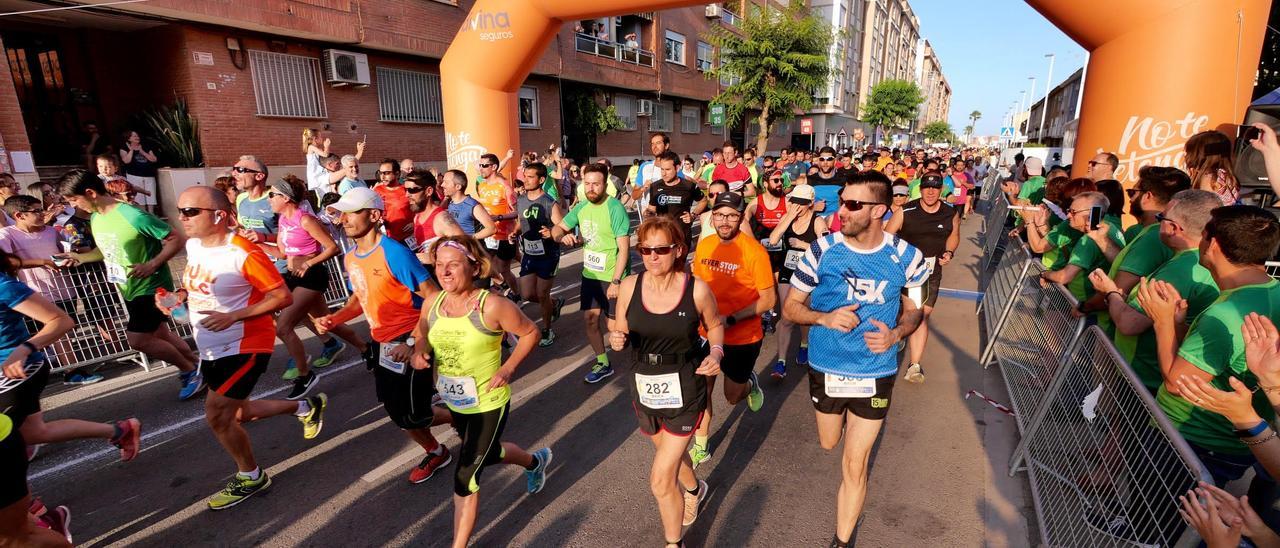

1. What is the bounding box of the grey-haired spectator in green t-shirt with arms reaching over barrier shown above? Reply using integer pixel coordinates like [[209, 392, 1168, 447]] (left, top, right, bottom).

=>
[[1089, 190, 1222, 394]]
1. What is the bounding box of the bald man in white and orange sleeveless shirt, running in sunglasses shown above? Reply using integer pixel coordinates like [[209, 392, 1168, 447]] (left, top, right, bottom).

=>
[[170, 186, 328, 510]]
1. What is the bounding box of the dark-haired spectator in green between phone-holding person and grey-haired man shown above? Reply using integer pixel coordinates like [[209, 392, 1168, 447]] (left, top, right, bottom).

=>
[[1082, 165, 1192, 334]]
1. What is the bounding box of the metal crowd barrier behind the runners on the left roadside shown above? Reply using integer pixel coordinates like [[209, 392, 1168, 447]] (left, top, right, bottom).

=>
[[27, 255, 351, 373]]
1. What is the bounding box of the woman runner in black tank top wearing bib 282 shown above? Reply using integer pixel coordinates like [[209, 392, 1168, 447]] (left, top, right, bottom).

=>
[[609, 215, 741, 547]]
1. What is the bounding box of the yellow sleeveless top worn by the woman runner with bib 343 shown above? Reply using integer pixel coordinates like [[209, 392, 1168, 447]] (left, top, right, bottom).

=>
[[426, 291, 511, 414]]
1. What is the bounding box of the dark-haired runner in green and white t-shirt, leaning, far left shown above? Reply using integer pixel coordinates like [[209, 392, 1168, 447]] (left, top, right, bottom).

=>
[[58, 164, 200, 399]]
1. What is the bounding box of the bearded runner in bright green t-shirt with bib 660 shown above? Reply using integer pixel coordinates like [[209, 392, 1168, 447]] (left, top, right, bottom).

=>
[[552, 164, 631, 383]]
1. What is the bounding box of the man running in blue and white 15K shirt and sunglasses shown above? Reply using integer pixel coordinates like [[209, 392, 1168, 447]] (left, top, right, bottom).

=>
[[782, 170, 929, 547]]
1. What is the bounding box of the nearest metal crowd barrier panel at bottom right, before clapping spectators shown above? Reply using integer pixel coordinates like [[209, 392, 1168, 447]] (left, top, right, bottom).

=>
[[1015, 326, 1212, 547]]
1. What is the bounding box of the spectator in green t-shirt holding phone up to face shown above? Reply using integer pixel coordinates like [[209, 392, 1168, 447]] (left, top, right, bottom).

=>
[[1041, 192, 1124, 308]]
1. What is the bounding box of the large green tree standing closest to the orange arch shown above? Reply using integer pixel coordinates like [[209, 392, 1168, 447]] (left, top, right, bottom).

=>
[[705, 1, 838, 154]]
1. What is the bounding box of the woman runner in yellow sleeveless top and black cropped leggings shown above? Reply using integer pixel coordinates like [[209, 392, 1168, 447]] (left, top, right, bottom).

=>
[[413, 236, 552, 547]]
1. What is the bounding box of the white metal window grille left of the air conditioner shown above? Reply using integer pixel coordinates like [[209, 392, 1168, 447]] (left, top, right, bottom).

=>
[[248, 50, 329, 118]]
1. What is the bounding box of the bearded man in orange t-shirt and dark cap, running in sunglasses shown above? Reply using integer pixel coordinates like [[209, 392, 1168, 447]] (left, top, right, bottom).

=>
[[689, 191, 778, 467]]
